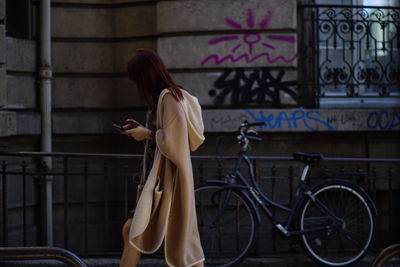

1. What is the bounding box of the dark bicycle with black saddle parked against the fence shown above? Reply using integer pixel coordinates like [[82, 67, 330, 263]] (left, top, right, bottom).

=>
[[195, 121, 377, 267]]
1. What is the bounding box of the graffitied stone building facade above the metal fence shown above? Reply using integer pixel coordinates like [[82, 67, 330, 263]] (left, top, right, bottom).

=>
[[0, 0, 400, 157]]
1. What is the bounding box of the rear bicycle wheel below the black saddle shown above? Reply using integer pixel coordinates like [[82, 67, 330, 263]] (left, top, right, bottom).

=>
[[298, 180, 375, 266]]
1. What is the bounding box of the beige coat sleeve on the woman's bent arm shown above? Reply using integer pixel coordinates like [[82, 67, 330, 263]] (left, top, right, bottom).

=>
[[155, 94, 189, 165]]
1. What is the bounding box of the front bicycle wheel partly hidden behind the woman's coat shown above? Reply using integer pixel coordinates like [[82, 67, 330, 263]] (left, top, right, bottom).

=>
[[195, 185, 256, 267]]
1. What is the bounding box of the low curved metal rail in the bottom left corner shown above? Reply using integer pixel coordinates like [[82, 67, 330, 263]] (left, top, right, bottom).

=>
[[0, 247, 86, 267]]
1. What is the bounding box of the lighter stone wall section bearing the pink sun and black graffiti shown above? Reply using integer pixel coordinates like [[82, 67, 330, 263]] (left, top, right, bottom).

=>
[[157, 0, 298, 107]]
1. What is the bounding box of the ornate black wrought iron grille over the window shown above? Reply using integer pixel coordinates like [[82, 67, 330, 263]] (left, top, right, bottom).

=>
[[300, 5, 400, 106]]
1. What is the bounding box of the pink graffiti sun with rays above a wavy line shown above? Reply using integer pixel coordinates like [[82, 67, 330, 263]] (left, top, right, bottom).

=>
[[200, 9, 297, 65]]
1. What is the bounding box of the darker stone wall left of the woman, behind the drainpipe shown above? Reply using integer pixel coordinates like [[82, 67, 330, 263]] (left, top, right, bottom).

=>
[[0, 0, 157, 153]]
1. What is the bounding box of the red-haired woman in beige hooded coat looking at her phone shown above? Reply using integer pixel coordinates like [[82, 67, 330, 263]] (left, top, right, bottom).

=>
[[121, 49, 204, 267]]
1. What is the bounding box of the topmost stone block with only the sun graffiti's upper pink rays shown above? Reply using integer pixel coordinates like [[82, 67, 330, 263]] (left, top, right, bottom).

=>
[[157, 0, 297, 33]]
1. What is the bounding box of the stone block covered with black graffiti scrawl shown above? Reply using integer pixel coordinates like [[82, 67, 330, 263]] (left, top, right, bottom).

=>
[[173, 68, 298, 107]]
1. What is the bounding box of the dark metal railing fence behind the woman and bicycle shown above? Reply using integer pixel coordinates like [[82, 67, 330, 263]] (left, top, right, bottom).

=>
[[0, 153, 400, 256]]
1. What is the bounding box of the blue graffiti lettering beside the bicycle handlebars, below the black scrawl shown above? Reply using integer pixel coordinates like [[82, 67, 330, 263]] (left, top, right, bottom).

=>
[[244, 109, 335, 131]]
